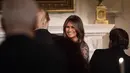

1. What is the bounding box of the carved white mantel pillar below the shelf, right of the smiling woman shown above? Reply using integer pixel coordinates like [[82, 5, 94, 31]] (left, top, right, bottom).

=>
[[85, 33, 105, 59]]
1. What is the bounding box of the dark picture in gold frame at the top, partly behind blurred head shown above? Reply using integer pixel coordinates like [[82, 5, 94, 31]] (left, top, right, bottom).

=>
[[0, 0, 75, 12]]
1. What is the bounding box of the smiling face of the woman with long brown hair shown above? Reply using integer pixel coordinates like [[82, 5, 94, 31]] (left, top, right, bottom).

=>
[[65, 22, 77, 39]]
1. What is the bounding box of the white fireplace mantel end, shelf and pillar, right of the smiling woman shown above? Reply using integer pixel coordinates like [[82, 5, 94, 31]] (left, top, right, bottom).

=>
[[84, 24, 115, 59]]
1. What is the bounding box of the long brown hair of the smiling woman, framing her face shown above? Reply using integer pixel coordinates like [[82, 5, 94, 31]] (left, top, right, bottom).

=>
[[63, 15, 84, 42]]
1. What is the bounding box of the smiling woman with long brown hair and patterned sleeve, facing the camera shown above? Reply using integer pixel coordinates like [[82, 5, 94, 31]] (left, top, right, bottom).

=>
[[63, 15, 89, 61]]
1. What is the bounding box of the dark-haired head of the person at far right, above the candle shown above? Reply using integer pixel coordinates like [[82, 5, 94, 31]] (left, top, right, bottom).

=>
[[109, 28, 129, 49]]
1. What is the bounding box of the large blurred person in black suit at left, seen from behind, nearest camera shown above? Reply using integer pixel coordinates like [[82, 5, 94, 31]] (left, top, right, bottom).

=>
[[0, 0, 68, 73]]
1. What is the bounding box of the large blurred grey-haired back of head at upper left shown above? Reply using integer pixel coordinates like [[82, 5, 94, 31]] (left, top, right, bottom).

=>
[[2, 0, 38, 33]]
